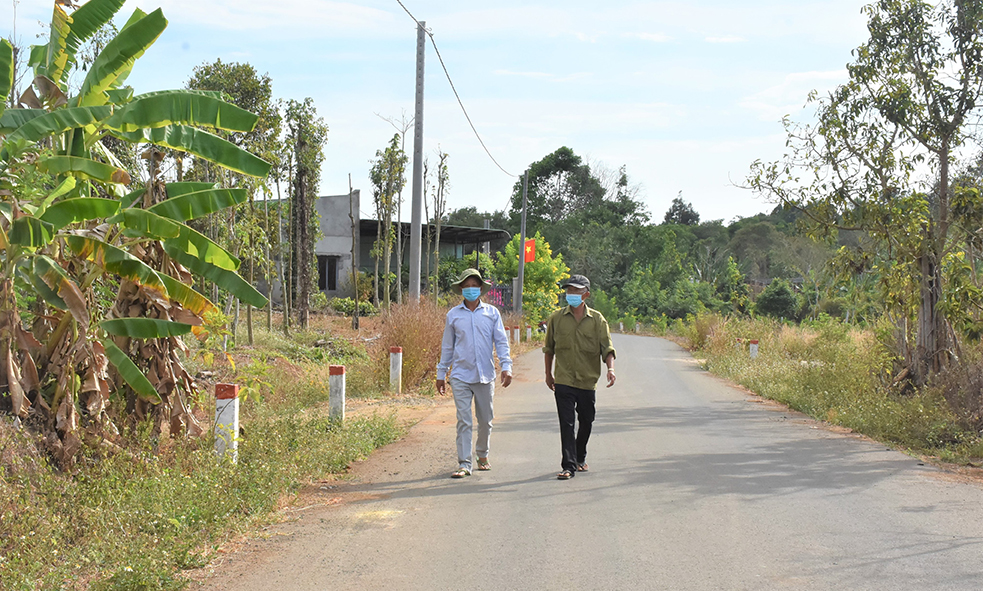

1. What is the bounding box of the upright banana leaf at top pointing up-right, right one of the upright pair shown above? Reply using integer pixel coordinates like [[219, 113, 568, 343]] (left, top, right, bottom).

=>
[[78, 8, 167, 107]]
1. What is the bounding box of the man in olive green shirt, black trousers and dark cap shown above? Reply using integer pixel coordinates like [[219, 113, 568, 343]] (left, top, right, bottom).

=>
[[543, 275, 616, 480]]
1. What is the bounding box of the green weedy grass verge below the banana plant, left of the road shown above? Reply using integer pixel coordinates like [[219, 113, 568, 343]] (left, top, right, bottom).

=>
[[0, 408, 400, 591]]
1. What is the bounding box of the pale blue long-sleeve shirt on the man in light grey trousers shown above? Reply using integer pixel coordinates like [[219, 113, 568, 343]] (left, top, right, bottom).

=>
[[437, 302, 512, 384]]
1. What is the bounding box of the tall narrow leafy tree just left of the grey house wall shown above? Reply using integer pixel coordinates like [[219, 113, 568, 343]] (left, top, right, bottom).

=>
[[285, 97, 328, 330]]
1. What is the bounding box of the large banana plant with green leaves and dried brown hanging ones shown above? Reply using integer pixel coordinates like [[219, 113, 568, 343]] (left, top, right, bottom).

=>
[[0, 0, 270, 467]]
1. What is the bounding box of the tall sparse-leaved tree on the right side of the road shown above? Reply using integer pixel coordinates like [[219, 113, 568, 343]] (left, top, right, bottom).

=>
[[749, 0, 983, 384]]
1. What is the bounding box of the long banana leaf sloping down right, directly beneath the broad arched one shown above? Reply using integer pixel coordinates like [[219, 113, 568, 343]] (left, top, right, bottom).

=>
[[116, 125, 272, 178]]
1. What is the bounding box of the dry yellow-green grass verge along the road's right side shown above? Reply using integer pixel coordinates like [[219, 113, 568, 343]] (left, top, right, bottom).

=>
[[681, 317, 983, 464]]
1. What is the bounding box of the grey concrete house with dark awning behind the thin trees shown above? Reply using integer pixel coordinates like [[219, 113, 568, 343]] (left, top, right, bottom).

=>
[[259, 190, 512, 303]]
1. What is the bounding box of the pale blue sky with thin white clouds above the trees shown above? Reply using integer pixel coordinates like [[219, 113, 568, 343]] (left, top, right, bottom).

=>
[[0, 0, 867, 223]]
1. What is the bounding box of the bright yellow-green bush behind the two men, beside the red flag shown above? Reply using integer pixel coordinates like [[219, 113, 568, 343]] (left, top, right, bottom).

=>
[[495, 232, 570, 324]]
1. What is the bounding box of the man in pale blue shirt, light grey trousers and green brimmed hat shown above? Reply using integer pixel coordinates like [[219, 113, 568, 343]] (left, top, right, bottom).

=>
[[437, 269, 512, 478]]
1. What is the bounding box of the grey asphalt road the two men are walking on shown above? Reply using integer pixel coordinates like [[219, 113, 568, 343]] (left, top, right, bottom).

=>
[[198, 335, 983, 591]]
